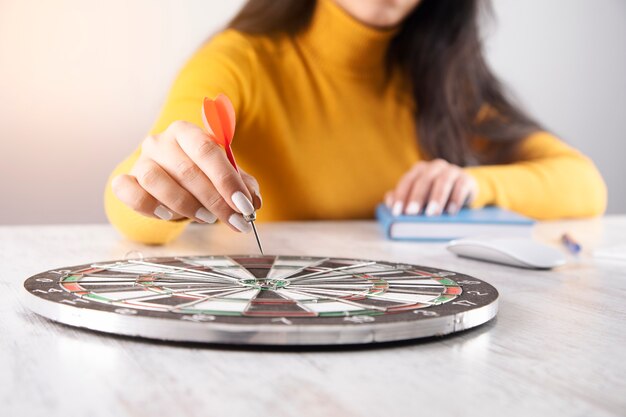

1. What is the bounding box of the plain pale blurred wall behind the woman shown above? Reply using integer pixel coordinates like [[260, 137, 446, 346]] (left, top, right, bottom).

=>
[[0, 0, 626, 224]]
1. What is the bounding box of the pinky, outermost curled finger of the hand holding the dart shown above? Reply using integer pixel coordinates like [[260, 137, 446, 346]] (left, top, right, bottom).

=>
[[111, 175, 168, 220]]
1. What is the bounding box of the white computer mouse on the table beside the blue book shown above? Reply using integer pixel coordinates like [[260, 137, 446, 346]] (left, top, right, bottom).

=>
[[446, 238, 567, 269]]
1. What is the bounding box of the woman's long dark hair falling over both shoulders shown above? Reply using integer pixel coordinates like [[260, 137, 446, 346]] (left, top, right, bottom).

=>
[[228, 0, 539, 166]]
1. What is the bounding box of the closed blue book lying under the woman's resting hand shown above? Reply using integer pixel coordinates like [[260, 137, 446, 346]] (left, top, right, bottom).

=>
[[376, 204, 535, 242]]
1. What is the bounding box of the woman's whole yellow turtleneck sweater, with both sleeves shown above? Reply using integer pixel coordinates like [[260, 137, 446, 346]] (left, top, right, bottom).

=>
[[105, 0, 606, 243]]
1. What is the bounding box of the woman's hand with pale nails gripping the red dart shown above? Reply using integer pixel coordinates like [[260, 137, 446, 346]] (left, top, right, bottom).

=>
[[112, 121, 261, 232]]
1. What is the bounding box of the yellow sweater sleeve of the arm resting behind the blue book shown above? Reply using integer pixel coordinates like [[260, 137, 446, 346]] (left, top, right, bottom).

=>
[[465, 132, 607, 220]]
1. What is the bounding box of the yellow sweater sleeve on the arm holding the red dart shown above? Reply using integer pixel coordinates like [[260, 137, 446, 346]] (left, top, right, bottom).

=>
[[104, 30, 252, 244]]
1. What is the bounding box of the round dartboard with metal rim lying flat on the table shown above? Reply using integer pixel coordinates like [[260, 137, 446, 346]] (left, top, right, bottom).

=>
[[24, 256, 498, 345]]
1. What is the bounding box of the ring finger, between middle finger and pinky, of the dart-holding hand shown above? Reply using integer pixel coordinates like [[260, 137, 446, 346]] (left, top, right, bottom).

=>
[[130, 159, 202, 220]]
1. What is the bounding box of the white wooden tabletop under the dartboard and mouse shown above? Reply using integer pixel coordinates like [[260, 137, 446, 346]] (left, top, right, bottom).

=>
[[0, 217, 626, 417]]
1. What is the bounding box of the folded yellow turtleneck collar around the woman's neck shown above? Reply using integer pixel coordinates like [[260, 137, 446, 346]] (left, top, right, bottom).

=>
[[300, 0, 398, 74]]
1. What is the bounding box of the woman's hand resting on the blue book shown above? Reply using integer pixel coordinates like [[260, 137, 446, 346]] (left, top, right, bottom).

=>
[[385, 159, 478, 216]]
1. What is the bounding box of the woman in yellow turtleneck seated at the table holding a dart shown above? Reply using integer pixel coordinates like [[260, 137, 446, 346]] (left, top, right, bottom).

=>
[[106, 0, 606, 243]]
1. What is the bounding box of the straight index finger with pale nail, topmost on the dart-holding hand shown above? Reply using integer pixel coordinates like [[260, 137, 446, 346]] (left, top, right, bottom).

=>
[[168, 122, 254, 215]]
